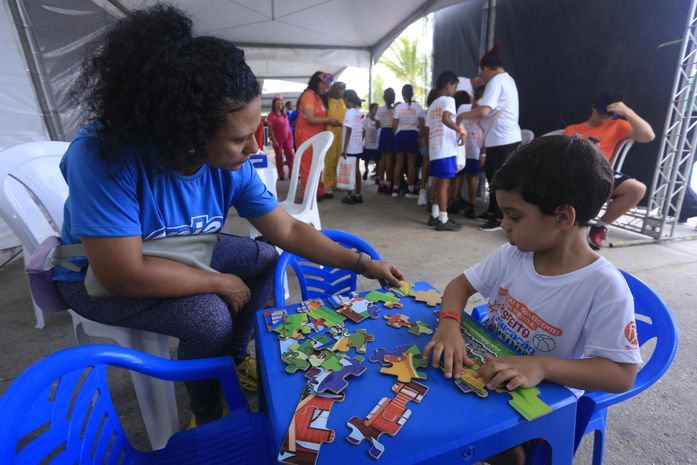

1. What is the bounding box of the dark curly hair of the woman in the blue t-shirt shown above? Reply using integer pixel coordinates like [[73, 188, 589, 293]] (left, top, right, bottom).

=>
[[72, 5, 260, 168]]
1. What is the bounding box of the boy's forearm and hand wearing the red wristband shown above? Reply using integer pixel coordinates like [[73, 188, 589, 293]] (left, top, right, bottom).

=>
[[423, 274, 477, 378]]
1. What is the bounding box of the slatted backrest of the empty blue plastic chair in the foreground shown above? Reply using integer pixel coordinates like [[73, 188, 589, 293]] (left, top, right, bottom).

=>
[[0, 346, 138, 465]]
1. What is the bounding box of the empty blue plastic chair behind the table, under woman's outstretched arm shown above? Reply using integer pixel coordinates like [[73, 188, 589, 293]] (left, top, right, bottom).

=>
[[274, 229, 381, 307]]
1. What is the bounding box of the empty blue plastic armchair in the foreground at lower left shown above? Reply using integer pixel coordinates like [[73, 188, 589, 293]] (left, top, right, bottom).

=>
[[0, 345, 274, 465]]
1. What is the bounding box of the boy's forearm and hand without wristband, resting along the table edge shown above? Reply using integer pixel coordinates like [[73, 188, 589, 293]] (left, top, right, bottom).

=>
[[476, 355, 639, 392]]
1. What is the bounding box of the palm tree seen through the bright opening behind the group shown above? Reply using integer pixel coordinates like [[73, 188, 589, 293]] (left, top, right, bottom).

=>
[[378, 37, 427, 103]]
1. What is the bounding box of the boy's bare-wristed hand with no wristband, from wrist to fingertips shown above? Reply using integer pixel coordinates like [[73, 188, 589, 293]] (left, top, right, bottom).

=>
[[475, 356, 545, 391]]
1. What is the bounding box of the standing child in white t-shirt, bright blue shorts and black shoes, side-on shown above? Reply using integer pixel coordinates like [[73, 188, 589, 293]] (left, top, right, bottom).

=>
[[426, 71, 467, 231]]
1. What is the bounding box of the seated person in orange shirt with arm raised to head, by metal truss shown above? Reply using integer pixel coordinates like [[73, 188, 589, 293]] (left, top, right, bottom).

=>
[[564, 92, 656, 250]]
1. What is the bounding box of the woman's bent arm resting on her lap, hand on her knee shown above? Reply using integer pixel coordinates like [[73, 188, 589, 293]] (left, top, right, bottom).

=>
[[80, 236, 249, 311]]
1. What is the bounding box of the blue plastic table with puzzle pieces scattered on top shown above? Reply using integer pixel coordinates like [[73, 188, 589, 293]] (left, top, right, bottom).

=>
[[256, 282, 576, 465]]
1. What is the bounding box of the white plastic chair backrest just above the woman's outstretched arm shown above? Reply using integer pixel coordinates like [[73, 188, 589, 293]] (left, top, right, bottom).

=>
[[284, 131, 334, 211]]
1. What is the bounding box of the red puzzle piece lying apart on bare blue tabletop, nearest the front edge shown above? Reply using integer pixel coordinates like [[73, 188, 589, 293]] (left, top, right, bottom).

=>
[[346, 381, 428, 460]]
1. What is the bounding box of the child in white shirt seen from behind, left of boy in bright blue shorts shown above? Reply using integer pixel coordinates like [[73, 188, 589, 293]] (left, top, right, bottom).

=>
[[392, 84, 424, 199]]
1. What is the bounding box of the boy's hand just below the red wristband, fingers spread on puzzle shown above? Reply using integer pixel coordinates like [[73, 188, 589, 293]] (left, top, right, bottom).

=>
[[423, 318, 474, 378]]
